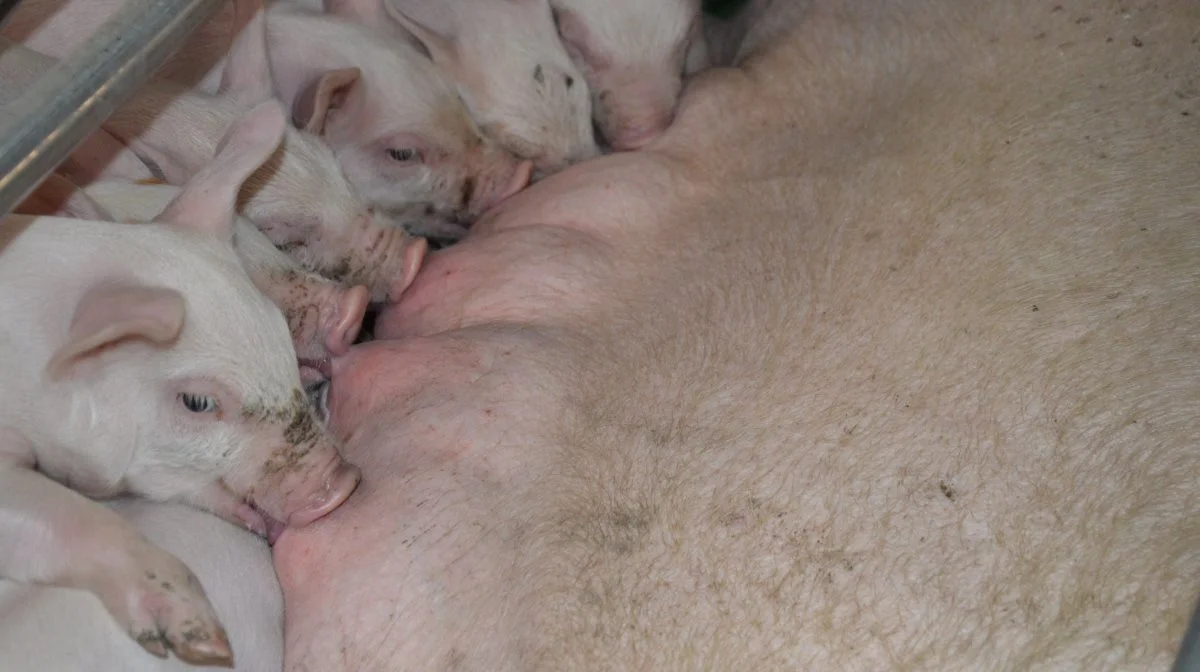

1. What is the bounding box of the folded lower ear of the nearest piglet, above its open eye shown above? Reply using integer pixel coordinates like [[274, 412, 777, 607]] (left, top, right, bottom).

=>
[[46, 282, 184, 379]]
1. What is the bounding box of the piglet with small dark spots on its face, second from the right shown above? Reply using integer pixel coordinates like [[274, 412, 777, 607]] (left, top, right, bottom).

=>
[[324, 0, 599, 174]]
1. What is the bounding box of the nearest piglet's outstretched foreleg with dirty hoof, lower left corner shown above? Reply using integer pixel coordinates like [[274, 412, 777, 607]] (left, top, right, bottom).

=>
[[0, 460, 233, 667]]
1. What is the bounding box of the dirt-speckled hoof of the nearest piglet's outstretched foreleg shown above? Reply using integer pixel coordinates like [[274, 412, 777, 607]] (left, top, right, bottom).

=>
[[97, 548, 234, 667]]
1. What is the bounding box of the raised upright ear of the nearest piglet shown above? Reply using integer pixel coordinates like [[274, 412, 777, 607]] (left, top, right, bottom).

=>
[[156, 100, 287, 241]]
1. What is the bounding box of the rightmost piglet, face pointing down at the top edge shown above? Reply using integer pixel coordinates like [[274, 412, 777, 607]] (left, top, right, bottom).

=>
[[550, 0, 708, 151]]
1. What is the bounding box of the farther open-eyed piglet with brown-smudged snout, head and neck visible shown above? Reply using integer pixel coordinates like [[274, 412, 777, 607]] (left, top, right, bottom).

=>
[[268, 2, 533, 228]]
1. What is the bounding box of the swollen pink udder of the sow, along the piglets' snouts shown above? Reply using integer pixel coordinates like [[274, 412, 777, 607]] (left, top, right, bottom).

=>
[[267, 155, 661, 671]]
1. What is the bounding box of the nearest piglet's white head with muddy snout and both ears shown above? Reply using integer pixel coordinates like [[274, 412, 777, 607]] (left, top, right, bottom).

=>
[[47, 102, 359, 540]]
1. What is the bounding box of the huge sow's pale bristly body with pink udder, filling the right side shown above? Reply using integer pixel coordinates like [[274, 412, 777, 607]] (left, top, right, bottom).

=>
[[275, 0, 1200, 672]]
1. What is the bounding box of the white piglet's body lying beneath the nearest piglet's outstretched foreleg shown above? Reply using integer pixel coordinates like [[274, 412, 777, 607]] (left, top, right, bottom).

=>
[[0, 498, 283, 672]]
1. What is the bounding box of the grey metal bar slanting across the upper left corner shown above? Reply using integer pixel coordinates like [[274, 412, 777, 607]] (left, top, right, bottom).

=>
[[0, 0, 222, 215]]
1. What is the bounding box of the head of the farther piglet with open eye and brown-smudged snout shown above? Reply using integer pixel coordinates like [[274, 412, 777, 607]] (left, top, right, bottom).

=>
[[292, 24, 532, 233]]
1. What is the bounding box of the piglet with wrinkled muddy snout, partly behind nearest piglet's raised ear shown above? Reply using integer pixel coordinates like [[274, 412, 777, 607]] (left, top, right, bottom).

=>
[[4, 5, 427, 301]]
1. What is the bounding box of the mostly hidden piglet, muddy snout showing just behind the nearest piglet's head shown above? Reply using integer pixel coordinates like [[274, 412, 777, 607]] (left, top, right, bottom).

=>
[[81, 180, 372, 371]]
